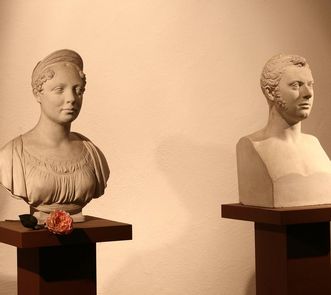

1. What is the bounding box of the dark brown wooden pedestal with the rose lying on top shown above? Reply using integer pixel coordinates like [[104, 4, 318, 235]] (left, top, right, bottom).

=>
[[0, 216, 132, 295]]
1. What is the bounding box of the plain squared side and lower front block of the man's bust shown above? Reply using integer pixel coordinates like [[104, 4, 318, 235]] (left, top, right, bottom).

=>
[[237, 138, 331, 208]]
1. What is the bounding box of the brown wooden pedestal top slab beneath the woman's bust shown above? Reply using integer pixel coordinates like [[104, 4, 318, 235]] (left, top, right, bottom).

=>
[[0, 216, 132, 248]]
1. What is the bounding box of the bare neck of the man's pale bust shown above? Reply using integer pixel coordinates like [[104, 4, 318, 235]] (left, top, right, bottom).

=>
[[263, 107, 301, 142]]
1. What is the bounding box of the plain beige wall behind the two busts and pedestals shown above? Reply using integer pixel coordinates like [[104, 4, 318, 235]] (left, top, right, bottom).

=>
[[0, 0, 331, 295]]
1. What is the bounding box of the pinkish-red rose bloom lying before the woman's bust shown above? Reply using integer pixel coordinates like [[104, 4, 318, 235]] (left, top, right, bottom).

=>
[[45, 210, 73, 235]]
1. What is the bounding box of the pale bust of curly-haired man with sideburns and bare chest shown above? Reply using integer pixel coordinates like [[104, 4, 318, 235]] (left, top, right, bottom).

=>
[[237, 55, 331, 207]]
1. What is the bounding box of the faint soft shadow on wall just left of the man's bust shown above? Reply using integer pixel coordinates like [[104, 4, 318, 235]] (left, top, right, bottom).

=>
[[156, 136, 237, 213]]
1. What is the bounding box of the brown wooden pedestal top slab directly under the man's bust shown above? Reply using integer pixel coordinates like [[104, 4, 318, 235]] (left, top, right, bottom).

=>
[[222, 203, 331, 225]]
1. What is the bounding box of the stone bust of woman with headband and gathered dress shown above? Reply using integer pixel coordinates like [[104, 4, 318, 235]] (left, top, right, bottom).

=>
[[0, 49, 109, 223]]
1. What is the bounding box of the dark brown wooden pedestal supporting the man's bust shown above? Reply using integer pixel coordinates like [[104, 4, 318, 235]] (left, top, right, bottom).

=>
[[222, 204, 331, 295]]
